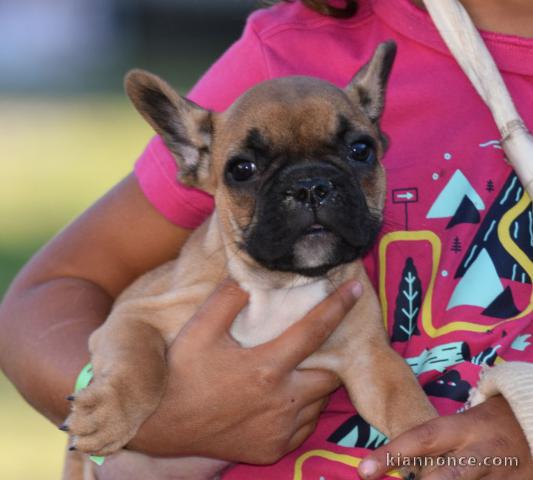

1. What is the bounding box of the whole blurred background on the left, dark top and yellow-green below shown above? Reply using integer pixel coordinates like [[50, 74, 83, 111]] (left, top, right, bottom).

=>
[[0, 0, 260, 480]]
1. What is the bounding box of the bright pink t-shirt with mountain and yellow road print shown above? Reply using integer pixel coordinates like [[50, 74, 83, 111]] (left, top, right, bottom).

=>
[[135, 0, 533, 480]]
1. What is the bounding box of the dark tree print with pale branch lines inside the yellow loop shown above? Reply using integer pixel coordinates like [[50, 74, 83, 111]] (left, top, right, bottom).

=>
[[391, 257, 422, 342]]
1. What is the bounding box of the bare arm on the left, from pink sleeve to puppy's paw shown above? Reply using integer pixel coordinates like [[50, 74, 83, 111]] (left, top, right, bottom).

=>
[[0, 175, 193, 423]]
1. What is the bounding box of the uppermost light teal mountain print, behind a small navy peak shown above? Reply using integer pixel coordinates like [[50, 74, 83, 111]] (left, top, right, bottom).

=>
[[427, 170, 485, 218]]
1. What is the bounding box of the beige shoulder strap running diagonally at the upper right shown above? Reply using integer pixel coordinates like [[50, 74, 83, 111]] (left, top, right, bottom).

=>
[[424, 0, 533, 198]]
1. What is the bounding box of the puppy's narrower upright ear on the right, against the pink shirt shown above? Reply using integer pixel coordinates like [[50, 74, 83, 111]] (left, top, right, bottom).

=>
[[345, 41, 396, 122]]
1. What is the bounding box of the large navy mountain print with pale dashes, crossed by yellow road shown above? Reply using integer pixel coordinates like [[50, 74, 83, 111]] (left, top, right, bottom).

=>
[[455, 173, 533, 284]]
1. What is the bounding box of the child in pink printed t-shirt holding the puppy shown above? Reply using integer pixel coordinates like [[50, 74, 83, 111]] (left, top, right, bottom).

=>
[[0, 0, 533, 480]]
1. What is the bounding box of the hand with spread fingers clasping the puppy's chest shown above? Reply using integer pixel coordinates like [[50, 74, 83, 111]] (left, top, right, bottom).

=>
[[130, 281, 361, 464]]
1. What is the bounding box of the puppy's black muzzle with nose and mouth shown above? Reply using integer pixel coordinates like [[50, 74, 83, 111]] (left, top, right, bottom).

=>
[[245, 161, 380, 276]]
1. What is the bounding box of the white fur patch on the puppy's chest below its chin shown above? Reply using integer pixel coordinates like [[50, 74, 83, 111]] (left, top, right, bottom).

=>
[[231, 280, 328, 347]]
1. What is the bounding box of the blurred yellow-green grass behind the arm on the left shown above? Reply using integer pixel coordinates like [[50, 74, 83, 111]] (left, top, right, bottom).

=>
[[0, 95, 152, 480]]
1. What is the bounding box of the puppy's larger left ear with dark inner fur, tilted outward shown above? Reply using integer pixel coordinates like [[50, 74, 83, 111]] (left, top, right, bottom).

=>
[[124, 70, 213, 191]]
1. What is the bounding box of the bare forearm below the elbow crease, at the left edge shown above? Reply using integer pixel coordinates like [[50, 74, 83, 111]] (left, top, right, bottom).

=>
[[0, 278, 113, 424]]
